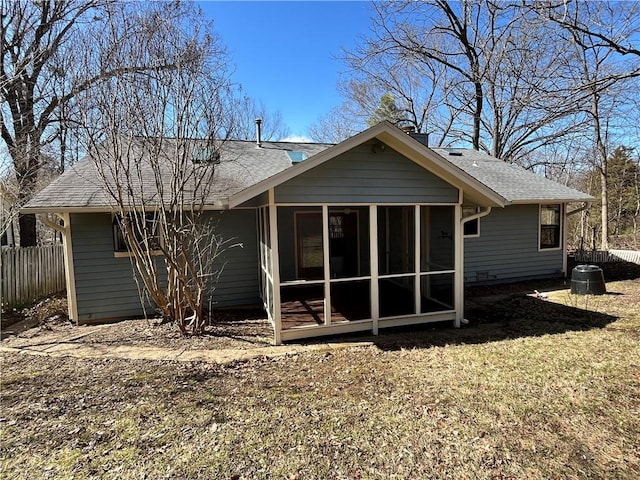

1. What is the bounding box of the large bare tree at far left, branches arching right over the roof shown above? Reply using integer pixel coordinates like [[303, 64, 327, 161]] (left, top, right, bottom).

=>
[[0, 0, 218, 245]]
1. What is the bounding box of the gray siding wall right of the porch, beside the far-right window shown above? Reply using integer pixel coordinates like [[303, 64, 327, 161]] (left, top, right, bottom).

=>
[[464, 204, 562, 284]]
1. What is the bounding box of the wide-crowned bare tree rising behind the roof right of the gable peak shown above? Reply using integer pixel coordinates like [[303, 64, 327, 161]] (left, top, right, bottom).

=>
[[338, 0, 584, 161]]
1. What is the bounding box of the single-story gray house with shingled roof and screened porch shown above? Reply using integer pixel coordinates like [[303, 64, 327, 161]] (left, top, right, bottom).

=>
[[23, 122, 593, 343]]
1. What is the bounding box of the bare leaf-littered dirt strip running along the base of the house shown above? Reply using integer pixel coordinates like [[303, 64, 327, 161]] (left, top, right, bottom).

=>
[[2, 263, 640, 350]]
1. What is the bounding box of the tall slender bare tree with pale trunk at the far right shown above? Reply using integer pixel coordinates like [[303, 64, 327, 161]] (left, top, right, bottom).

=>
[[533, 1, 640, 250]]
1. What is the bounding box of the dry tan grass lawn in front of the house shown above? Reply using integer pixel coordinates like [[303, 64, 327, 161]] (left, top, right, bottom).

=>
[[0, 279, 640, 479]]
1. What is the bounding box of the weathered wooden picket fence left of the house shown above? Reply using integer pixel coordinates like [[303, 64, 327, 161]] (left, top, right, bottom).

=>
[[0, 245, 66, 308]]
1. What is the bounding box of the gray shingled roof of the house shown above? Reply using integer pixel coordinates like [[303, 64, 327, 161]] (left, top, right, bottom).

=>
[[25, 136, 593, 211]]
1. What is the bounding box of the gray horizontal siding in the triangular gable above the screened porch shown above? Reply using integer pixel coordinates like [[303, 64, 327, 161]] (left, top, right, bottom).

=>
[[275, 140, 458, 204]]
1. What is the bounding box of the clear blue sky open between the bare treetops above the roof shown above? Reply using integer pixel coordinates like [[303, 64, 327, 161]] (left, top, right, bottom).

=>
[[200, 1, 371, 141]]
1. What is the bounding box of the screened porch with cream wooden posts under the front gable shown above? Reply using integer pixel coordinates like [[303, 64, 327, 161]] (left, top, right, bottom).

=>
[[258, 205, 459, 342]]
